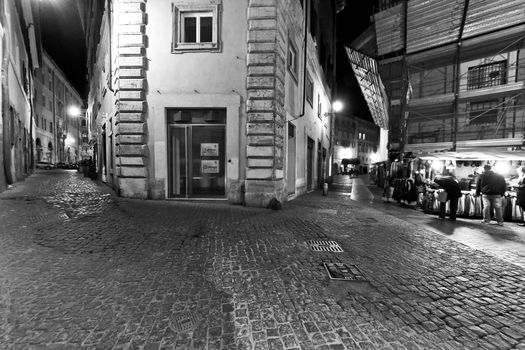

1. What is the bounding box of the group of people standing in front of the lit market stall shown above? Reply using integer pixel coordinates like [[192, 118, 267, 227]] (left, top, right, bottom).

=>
[[434, 164, 525, 226]]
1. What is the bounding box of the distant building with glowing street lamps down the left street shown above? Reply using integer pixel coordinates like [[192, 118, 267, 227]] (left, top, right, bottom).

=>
[[34, 51, 84, 164]]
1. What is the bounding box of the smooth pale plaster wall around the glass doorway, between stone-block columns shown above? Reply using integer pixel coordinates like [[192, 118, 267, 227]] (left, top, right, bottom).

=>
[[146, 0, 247, 197]]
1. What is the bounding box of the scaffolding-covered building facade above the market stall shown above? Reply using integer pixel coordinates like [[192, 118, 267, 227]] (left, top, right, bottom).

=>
[[352, 0, 525, 155]]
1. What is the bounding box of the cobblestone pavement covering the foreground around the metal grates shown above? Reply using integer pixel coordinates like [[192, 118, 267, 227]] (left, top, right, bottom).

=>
[[0, 170, 525, 350]]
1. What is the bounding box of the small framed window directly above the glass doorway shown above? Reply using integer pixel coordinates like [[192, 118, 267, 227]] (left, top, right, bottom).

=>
[[172, 4, 220, 53]]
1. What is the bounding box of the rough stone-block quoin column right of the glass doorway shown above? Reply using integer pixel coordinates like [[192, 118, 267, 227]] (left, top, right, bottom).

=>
[[245, 0, 286, 207]]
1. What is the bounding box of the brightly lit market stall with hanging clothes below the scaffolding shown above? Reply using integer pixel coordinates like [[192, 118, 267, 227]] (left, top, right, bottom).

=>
[[383, 150, 525, 221]]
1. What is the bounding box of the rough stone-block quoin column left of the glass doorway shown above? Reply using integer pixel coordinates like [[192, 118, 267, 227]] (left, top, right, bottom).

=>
[[113, 0, 148, 198]]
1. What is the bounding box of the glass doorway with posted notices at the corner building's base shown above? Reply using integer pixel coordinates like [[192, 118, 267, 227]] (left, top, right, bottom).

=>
[[168, 109, 226, 198]]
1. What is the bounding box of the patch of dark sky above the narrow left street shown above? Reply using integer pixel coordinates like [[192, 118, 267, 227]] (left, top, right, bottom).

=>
[[40, 0, 86, 98]]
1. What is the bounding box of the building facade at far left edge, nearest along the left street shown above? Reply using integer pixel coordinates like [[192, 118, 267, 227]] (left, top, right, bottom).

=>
[[0, 0, 39, 191]]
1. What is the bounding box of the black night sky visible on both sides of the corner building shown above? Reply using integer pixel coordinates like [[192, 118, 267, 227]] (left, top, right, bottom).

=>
[[40, 0, 374, 119]]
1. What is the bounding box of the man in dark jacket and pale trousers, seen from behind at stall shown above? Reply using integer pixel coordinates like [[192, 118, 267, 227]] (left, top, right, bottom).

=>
[[476, 164, 507, 226]]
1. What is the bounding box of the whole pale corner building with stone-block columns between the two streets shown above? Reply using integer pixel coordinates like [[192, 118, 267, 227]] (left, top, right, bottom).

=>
[[79, 0, 342, 207]]
